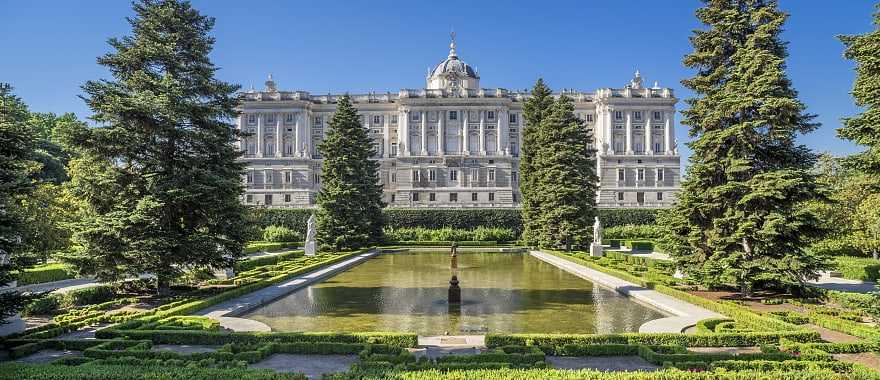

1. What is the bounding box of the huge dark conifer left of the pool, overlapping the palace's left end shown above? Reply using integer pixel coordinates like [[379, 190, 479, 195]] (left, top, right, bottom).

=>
[[64, 0, 247, 293]]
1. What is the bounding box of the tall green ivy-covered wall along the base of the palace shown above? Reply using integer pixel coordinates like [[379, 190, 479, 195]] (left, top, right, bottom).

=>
[[255, 208, 658, 233]]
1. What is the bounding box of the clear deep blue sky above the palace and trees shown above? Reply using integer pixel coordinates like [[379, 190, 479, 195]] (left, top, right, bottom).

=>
[[0, 0, 873, 164]]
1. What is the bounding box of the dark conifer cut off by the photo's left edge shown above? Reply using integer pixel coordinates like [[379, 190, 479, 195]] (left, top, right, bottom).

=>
[[0, 83, 39, 324]]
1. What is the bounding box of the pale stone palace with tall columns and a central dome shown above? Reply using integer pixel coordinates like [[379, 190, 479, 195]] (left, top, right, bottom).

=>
[[237, 39, 680, 208]]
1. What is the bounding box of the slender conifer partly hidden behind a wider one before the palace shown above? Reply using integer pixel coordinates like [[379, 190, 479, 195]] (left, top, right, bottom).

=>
[[519, 78, 553, 245]]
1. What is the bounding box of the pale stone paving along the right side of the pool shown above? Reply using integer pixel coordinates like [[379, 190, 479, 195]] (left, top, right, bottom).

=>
[[530, 251, 722, 333]]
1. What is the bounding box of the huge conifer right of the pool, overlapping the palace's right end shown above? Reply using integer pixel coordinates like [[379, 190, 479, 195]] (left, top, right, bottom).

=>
[[661, 0, 825, 296]]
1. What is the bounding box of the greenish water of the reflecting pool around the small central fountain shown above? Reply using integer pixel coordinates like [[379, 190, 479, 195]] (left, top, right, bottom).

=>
[[243, 251, 665, 335]]
